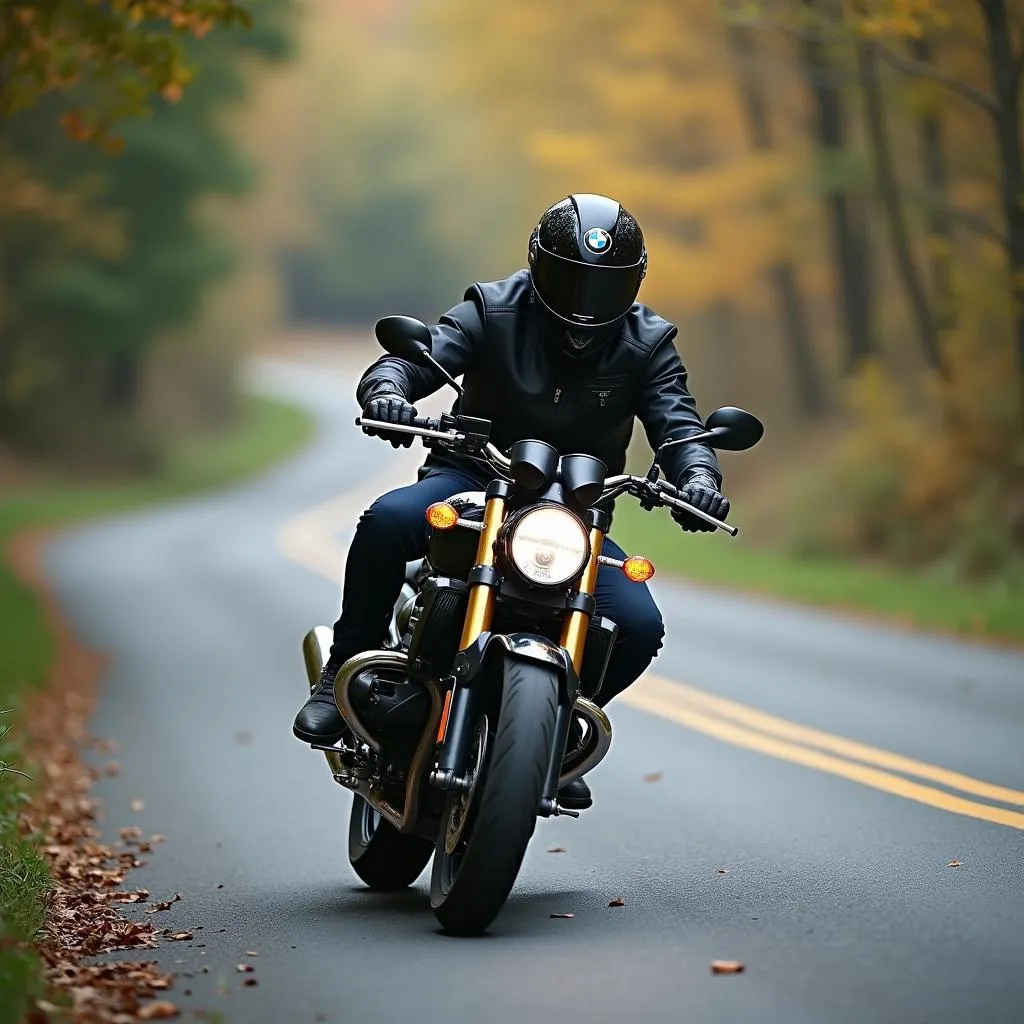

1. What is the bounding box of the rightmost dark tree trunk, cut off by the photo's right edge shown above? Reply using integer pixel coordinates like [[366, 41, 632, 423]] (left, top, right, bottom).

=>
[[981, 0, 1024, 414]]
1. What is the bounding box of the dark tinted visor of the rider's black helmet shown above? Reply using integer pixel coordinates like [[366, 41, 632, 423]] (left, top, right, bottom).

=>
[[534, 246, 643, 327]]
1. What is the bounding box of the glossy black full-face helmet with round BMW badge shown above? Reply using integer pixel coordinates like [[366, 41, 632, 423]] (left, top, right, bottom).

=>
[[529, 193, 647, 328]]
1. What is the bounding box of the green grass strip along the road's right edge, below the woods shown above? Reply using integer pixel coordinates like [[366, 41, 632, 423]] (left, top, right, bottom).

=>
[[614, 500, 1024, 642]]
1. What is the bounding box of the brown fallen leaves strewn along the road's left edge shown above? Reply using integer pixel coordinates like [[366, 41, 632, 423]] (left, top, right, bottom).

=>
[[10, 535, 180, 1024]]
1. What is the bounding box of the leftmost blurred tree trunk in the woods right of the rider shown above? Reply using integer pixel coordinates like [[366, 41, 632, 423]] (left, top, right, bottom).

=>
[[729, 27, 827, 419]]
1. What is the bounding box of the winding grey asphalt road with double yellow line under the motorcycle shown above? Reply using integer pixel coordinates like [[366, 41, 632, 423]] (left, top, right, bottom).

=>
[[48, 354, 1024, 1024]]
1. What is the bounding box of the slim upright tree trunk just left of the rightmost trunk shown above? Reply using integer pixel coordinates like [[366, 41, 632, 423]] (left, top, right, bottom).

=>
[[910, 39, 956, 333]]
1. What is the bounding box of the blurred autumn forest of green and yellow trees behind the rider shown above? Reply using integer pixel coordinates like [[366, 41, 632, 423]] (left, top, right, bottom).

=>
[[0, 0, 1024, 594]]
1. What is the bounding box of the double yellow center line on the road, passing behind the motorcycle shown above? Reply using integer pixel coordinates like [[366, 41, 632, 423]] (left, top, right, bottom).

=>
[[275, 479, 1024, 829]]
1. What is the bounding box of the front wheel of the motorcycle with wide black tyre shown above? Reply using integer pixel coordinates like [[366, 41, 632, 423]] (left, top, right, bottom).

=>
[[430, 659, 558, 935]]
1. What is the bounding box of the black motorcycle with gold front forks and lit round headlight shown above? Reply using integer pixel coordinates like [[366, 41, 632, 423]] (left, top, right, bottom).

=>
[[303, 316, 764, 935]]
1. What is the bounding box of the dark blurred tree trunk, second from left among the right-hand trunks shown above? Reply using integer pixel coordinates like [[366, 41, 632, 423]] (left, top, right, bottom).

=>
[[801, 0, 874, 371]]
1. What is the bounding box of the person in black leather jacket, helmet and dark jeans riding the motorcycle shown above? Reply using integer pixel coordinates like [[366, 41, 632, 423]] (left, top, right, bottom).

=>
[[294, 194, 729, 809]]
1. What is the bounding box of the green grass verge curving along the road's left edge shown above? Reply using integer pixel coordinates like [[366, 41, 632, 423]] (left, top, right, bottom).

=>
[[0, 389, 312, 1024]]
